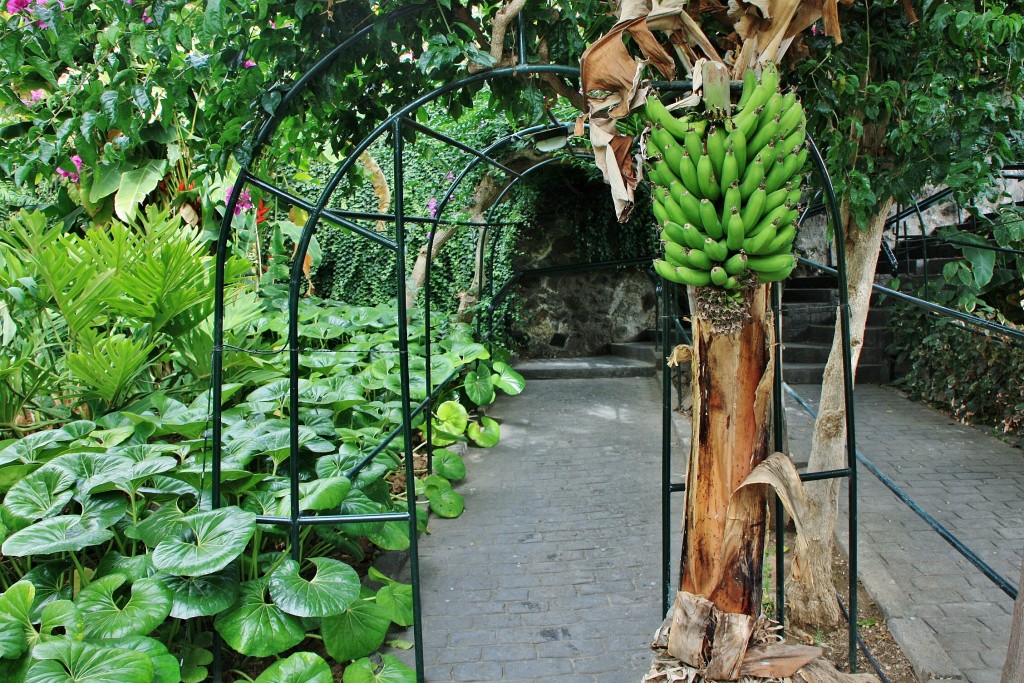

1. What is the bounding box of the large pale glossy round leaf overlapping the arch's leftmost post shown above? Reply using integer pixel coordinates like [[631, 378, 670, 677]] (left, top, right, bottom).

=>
[[153, 507, 256, 577]]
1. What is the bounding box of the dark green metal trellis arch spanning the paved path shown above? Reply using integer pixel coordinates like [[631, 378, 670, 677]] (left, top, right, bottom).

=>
[[211, 6, 856, 682]]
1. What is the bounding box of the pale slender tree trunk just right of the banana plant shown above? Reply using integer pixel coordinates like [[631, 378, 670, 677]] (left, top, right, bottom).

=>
[[785, 194, 893, 628]]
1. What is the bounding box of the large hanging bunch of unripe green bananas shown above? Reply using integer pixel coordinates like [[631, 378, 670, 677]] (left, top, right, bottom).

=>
[[645, 63, 807, 291]]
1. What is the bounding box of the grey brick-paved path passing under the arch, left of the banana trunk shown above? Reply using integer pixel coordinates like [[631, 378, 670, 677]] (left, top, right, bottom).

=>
[[402, 377, 678, 683]]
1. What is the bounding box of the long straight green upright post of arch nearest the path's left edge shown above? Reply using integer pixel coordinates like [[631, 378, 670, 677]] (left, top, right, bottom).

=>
[[392, 119, 430, 683]]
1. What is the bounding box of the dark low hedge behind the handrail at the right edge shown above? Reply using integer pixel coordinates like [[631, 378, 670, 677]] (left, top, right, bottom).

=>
[[890, 294, 1024, 436]]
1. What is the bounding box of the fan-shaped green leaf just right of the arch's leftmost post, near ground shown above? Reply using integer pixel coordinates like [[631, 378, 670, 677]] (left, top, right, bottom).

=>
[[214, 578, 306, 657]]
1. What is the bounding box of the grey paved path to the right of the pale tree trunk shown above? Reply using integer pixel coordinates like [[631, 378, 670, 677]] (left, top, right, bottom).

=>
[[786, 385, 1024, 683]]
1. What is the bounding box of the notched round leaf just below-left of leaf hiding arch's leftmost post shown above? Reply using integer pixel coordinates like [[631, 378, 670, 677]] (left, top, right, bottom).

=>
[[77, 573, 171, 638]]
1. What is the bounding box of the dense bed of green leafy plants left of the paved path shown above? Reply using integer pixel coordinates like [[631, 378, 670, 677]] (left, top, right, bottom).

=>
[[0, 209, 522, 683]]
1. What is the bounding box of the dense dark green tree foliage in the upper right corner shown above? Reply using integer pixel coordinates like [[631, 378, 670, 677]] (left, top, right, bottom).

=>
[[798, 0, 1024, 224]]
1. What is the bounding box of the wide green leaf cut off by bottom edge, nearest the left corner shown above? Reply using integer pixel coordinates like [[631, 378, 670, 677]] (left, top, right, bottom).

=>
[[25, 637, 155, 683]]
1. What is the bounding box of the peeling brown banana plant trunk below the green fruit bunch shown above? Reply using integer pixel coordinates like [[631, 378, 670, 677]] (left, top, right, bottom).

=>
[[680, 286, 775, 616]]
